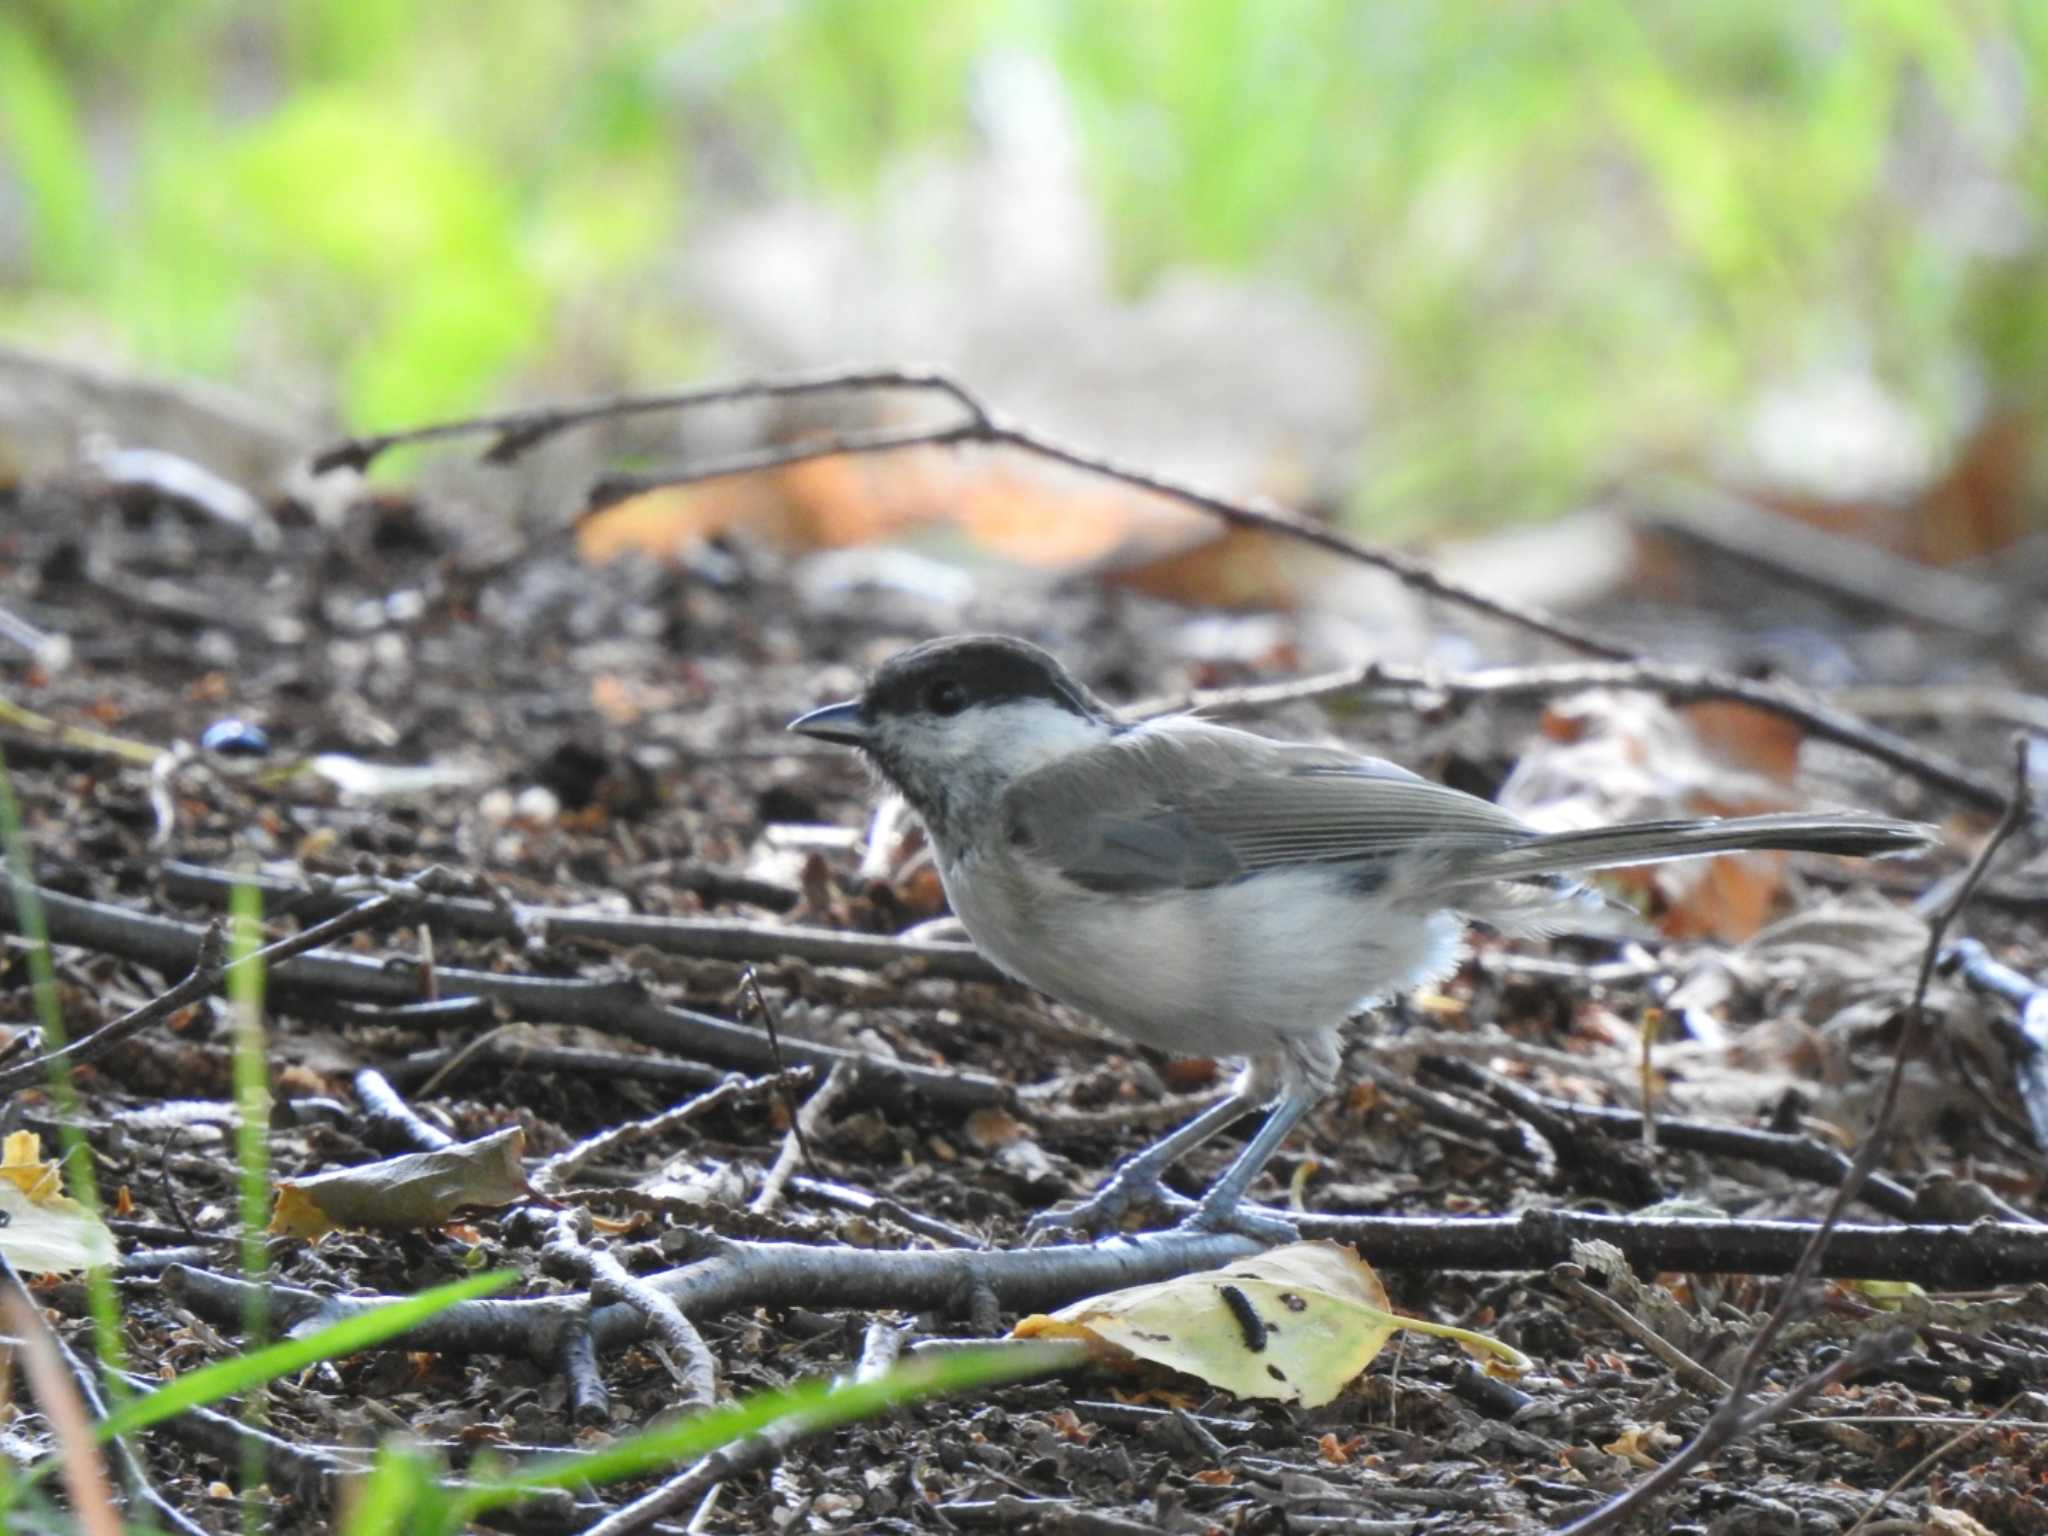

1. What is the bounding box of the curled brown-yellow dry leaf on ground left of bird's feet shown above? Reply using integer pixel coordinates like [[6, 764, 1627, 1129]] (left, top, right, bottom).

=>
[[270, 1126, 535, 1239]]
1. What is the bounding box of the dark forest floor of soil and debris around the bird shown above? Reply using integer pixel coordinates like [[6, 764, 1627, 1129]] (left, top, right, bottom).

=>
[[0, 438, 2048, 1536]]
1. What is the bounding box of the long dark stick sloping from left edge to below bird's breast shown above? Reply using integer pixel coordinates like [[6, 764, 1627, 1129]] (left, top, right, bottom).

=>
[[0, 885, 1010, 1110]]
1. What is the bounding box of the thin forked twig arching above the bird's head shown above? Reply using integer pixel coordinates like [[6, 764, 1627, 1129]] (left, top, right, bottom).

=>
[[313, 369, 1630, 659]]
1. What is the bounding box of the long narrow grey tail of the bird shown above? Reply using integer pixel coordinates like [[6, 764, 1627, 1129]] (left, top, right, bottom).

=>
[[1452, 813, 1935, 883]]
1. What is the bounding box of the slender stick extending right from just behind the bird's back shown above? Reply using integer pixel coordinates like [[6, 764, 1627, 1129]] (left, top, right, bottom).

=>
[[1171, 662, 2007, 813]]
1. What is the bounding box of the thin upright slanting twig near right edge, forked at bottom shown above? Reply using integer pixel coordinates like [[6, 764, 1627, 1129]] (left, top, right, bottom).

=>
[[1567, 737, 2034, 1536]]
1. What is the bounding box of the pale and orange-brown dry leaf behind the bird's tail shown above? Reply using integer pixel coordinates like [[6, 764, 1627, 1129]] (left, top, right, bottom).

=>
[[1501, 690, 1798, 942]]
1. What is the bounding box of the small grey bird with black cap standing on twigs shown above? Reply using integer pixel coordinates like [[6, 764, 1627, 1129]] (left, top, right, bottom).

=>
[[788, 635, 1929, 1241]]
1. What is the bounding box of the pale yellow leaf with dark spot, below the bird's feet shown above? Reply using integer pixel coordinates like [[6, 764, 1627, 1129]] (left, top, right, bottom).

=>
[[1014, 1241, 1532, 1407]]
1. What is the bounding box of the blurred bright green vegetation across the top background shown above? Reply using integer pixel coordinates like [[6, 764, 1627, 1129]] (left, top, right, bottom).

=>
[[0, 0, 2048, 532]]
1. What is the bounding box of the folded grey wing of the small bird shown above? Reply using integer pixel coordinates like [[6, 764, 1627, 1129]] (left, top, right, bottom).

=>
[[1004, 719, 1534, 893]]
